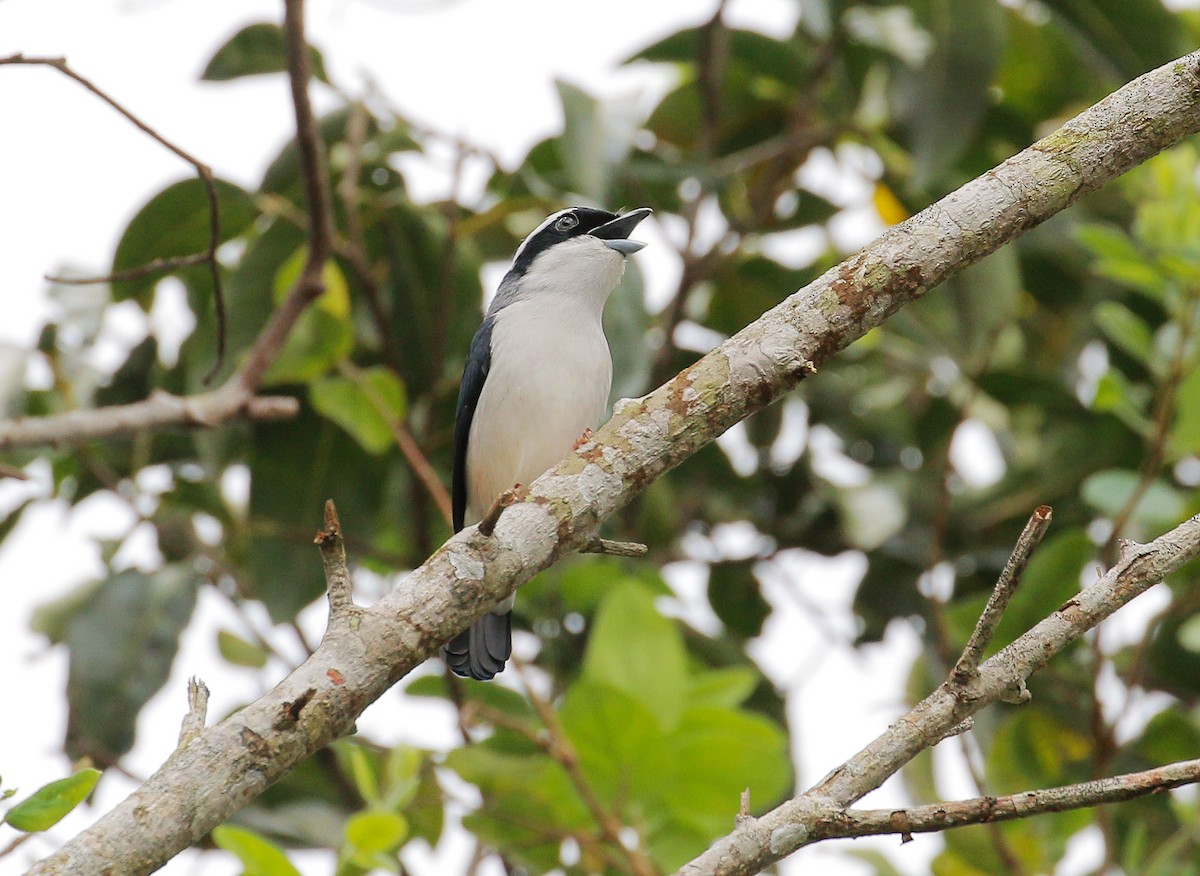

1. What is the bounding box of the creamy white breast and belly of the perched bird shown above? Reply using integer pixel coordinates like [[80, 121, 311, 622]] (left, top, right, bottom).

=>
[[466, 296, 619, 523]]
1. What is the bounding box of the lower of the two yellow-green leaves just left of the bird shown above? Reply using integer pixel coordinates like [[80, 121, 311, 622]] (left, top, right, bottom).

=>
[[308, 365, 407, 456]]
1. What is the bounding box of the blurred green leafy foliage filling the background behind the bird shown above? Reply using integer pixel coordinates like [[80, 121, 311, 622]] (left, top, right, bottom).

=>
[[7, 0, 1200, 874]]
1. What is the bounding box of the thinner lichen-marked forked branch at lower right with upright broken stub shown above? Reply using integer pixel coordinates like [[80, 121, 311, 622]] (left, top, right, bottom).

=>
[[677, 505, 1200, 876]]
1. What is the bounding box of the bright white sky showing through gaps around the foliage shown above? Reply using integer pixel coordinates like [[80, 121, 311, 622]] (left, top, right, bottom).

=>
[[0, 0, 1180, 876]]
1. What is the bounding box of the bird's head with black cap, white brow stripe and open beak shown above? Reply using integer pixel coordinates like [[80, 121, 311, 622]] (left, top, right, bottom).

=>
[[502, 206, 652, 307]]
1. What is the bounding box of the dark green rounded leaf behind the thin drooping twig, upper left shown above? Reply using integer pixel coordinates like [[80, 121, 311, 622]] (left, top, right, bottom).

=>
[[113, 179, 258, 310]]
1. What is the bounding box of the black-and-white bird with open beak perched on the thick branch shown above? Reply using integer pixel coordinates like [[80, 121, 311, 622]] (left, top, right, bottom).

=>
[[443, 206, 652, 680]]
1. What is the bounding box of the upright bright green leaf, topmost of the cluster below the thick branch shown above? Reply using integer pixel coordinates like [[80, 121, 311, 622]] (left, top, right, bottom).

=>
[[583, 583, 688, 728]]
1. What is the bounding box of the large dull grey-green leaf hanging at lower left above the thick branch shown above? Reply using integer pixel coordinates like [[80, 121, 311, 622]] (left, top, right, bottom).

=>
[[66, 565, 198, 763]]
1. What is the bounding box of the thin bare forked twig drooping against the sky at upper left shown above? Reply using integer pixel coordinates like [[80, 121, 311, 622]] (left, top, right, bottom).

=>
[[0, 52, 226, 383]]
